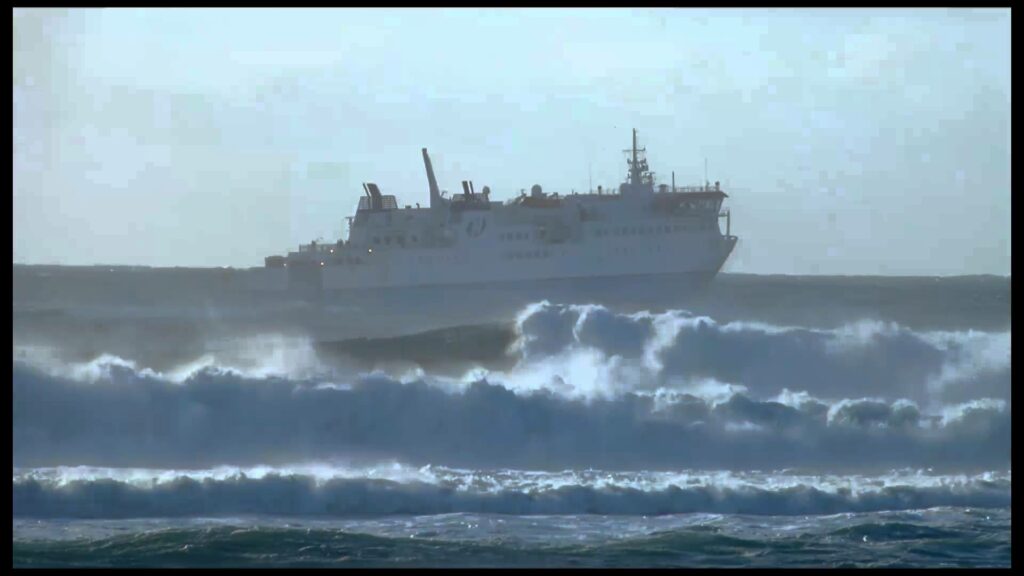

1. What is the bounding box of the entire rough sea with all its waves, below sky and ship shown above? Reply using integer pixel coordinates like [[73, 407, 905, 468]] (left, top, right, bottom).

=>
[[12, 266, 1012, 567]]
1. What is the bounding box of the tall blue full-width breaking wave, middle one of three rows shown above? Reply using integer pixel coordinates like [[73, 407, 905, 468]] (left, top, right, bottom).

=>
[[13, 364, 1011, 469]]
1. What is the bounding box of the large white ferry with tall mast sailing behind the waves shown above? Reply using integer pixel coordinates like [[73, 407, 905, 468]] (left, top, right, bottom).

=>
[[242, 129, 737, 319]]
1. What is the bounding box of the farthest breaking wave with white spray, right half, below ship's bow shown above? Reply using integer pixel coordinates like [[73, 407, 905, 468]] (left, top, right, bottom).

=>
[[510, 302, 1010, 403]]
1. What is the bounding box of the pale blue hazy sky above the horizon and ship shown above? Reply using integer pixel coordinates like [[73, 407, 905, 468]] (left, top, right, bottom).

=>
[[12, 8, 1011, 276]]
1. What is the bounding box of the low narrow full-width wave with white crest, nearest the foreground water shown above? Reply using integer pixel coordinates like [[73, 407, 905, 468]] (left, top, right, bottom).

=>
[[13, 464, 1011, 519]]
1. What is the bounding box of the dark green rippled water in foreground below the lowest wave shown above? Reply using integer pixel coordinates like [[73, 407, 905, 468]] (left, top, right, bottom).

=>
[[14, 508, 1011, 568]]
